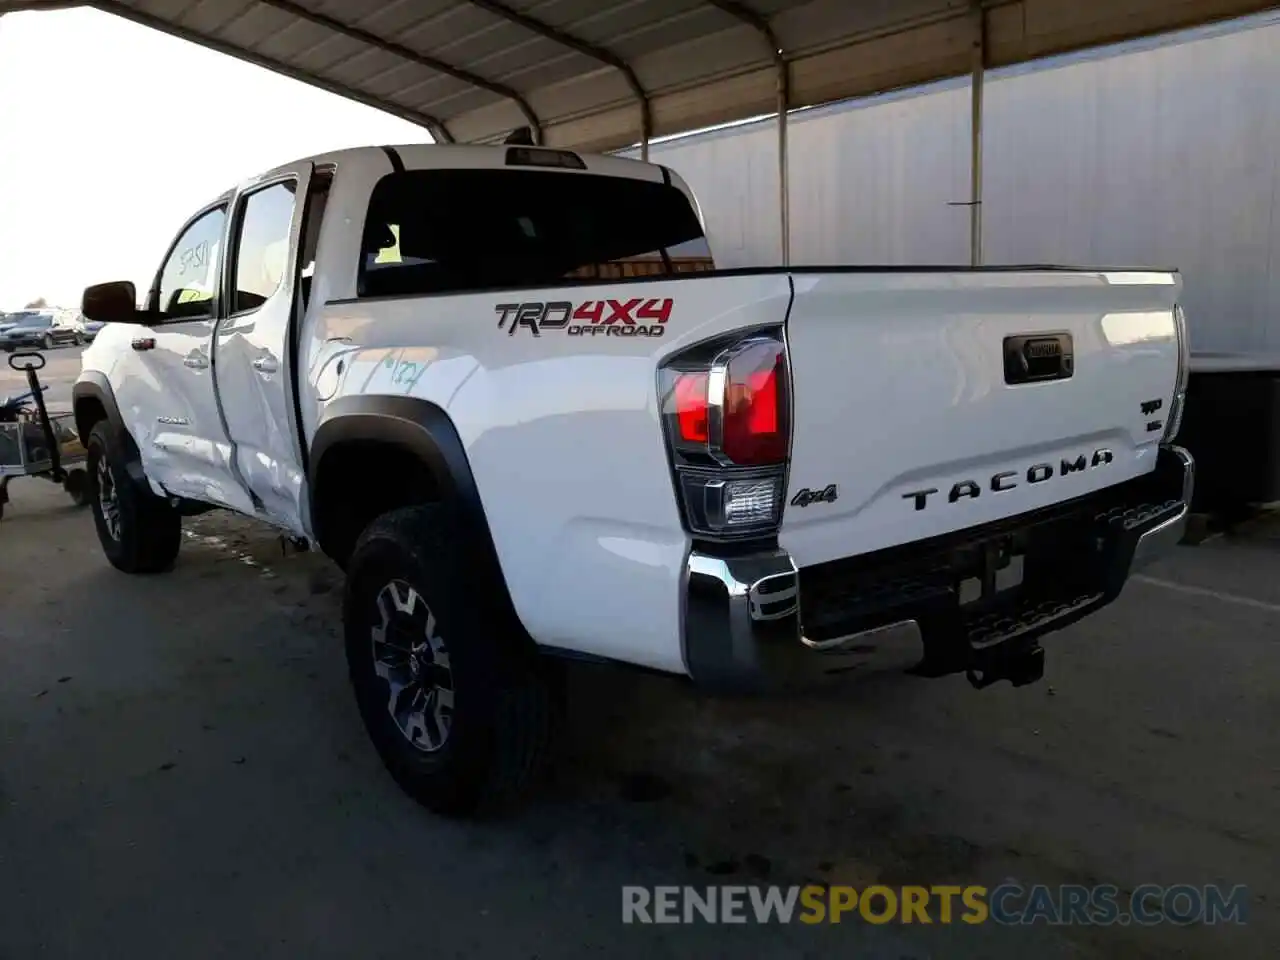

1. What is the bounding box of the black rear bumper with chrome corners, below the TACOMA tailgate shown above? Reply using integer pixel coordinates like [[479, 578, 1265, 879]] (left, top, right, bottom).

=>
[[682, 445, 1194, 692]]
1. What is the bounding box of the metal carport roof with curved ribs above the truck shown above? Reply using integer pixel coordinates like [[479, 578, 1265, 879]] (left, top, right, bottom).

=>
[[0, 0, 1276, 151]]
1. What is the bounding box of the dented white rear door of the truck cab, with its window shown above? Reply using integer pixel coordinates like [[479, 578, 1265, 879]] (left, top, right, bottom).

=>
[[215, 164, 312, 535]]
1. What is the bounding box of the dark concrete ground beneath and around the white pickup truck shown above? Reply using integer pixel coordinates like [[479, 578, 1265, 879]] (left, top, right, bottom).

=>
[[0, 351, 1280, 960]]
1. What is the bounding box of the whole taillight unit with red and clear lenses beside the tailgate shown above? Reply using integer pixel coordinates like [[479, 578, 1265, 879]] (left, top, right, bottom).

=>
[[660, 334, 790, 538]]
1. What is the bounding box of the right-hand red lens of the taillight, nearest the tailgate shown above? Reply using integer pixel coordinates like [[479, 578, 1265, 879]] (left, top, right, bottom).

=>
[[721, 340, 787, 466]]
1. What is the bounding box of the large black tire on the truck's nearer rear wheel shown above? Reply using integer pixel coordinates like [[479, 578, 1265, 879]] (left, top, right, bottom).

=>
[[343, 506, 553, 817]]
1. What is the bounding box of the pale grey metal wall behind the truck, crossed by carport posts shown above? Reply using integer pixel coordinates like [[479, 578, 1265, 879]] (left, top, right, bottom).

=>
[[632, 9, 1280, 352]]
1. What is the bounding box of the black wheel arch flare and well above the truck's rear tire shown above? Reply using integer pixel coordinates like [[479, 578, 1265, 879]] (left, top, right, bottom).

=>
[[308, 397, 527, 635]]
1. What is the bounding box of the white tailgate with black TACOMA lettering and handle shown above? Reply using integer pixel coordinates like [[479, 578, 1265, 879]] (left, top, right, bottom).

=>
[[780, 269, 1181, 567]]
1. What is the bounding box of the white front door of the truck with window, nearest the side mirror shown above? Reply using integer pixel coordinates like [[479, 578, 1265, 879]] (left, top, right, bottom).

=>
[[111, 202, 252, 509]]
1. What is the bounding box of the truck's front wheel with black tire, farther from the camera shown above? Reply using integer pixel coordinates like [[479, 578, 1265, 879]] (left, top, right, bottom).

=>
[[86, 420, 182, 573]]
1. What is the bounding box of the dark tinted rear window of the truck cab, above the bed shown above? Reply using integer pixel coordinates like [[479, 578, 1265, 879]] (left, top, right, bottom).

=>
[[360, 169, 714, 297]]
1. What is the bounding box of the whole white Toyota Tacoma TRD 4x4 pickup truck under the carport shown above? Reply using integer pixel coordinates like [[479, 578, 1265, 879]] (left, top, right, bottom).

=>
[[74, 146, 1193, 815]]
